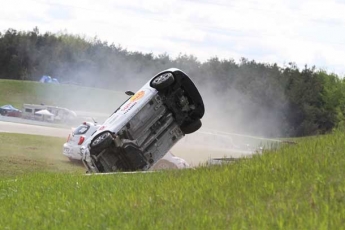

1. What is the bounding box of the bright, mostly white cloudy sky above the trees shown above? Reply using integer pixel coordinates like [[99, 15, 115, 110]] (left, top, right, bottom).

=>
[[0, 0, 345, 77]]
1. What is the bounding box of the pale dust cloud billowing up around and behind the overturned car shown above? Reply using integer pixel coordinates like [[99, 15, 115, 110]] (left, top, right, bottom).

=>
[[35, 49, 286, 163]]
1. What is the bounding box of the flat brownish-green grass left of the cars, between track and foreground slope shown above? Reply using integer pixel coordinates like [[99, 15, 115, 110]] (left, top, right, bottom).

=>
[[0, 133, 84, 178]]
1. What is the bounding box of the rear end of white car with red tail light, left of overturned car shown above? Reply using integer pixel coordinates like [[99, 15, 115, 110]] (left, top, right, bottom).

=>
[[63, 122, 101, 161]]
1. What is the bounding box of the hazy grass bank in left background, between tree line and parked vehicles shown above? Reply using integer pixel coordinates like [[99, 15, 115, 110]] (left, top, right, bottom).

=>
[[0, 79, 127, 114]]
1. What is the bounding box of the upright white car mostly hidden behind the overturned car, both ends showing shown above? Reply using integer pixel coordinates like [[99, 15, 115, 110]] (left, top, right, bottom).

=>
[[63, 122, 189, 170]]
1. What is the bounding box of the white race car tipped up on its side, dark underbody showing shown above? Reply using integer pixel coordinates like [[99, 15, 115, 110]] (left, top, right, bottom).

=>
[[81, 68, 205, 173]]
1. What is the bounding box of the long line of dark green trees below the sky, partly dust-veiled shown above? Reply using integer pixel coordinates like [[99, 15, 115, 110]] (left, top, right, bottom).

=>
[[0, 28, 345, 137]]
